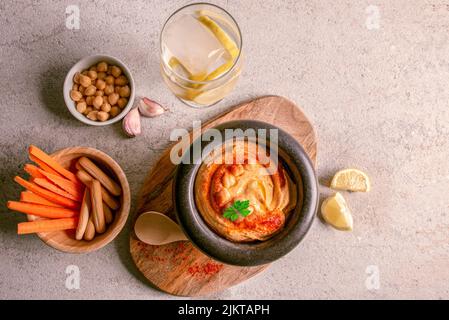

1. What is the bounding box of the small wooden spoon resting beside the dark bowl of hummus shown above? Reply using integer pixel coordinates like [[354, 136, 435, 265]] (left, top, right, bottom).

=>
[[134, 211, 188, 246]]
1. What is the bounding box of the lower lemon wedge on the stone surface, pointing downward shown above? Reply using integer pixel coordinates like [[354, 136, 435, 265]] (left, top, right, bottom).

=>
[[321, 192, 353, 231]]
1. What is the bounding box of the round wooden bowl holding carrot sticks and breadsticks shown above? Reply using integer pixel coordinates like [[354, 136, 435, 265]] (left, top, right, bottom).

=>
[[28, 147, 131, 253]]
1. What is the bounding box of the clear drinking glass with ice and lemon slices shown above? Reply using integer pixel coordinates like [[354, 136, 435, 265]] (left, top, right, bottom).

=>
[[160, 3, 243, 108]]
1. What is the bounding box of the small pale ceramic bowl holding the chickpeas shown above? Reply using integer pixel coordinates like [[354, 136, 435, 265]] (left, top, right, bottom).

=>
[[63, 54, 135, 126]]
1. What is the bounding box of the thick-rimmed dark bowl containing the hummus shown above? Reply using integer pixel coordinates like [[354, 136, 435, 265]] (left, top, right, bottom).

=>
[[173, 120, 318, 266]]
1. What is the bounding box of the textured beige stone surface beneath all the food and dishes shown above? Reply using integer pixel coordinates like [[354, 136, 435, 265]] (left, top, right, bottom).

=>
[[0, 0, 449, 299]]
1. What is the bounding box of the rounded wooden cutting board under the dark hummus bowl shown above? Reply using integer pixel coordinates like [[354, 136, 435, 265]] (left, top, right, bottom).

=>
[[130, 96, 317, 296]]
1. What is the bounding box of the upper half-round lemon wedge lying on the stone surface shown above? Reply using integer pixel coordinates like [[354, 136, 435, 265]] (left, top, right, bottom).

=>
[[330, 169, 371, 192]]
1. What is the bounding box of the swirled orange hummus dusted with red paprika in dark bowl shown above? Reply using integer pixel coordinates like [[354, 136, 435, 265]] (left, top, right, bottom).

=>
[[194, 141, 297, 242]]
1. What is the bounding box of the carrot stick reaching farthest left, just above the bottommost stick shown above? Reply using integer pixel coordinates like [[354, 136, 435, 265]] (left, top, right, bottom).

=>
[[7, 201, 79, 219]]
